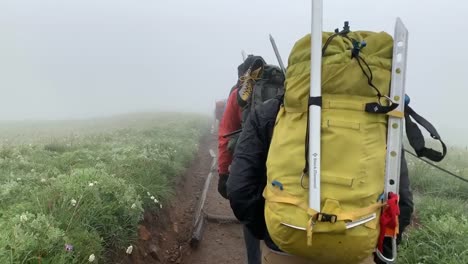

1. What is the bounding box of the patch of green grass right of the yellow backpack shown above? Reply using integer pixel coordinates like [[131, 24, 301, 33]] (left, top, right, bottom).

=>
[[399, 148, 468, 264]]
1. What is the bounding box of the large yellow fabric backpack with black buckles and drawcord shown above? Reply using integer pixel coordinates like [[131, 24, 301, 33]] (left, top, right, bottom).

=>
[[264, 31, 393, 264]]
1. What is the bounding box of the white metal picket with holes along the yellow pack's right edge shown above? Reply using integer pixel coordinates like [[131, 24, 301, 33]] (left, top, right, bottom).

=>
[[376, 18, 408, 263]]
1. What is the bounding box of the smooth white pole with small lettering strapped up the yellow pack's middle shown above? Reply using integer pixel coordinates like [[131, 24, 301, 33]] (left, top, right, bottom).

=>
[[308, 0, 323, 212]]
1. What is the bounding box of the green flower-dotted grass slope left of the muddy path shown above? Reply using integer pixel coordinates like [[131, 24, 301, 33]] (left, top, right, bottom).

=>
[[0, 114, 208, 264]]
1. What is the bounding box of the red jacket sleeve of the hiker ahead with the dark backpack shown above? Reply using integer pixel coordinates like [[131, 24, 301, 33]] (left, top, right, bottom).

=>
[[218, 88, 242, 174]]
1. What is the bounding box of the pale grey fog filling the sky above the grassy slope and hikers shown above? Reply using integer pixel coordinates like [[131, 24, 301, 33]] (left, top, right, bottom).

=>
[[0, 0, 468, 143]]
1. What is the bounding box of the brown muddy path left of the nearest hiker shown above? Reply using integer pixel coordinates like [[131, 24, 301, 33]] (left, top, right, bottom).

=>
[[113, 134, 245, 264]]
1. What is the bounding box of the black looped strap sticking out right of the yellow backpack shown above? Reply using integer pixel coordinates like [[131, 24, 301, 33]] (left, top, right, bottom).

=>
[[405, 105, 447, 162]]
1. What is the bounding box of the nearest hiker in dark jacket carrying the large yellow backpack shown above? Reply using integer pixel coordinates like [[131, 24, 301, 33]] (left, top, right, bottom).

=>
[[228, 25, 446, 263]]
